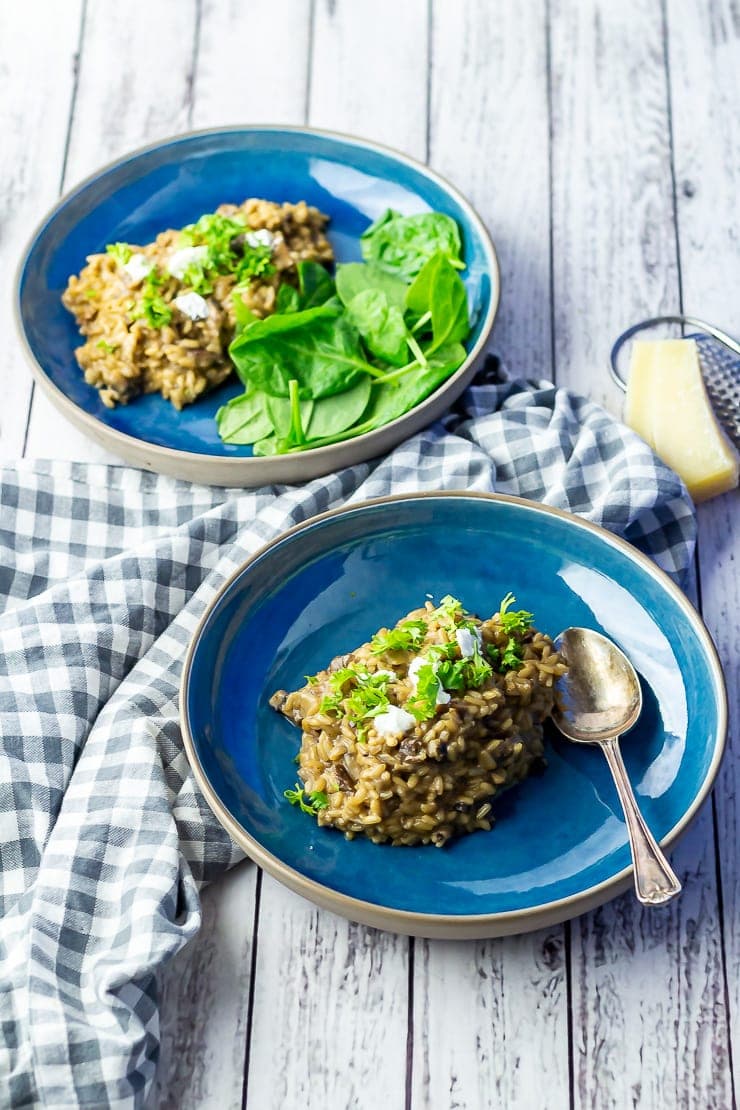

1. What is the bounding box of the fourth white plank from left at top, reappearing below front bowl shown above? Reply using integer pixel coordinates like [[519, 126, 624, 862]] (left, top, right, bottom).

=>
[[246, 0, 426, 1110]]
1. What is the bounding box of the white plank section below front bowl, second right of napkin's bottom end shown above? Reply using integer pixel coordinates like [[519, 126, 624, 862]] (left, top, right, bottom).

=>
[[246, 875, 407, 1110]]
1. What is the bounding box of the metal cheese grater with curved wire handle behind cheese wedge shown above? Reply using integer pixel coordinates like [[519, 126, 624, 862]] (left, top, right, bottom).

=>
[[609, 315, 740, 447]]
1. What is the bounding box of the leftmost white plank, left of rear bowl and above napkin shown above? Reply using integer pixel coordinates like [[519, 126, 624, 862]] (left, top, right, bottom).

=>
[[0, 0, 81, 458]]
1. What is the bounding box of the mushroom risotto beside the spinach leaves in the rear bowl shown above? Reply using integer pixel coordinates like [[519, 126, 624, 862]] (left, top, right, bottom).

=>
[[62, 198, 334, 408]]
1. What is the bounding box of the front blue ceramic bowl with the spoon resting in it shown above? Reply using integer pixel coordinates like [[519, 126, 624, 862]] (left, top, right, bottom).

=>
[[181, 494, 727, 937]]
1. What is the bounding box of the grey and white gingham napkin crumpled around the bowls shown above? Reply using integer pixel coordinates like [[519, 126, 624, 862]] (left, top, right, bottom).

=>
[[0, 363, 695, 1110]]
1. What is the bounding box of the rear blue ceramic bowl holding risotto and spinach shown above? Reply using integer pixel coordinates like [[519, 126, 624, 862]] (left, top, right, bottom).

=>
[[17, 128, 499, 485]]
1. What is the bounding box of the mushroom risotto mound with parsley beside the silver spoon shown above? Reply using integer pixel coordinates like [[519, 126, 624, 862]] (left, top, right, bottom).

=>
[[271, 595, 566, 847]]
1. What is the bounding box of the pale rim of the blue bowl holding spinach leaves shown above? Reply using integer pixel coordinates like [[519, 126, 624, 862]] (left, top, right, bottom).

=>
[[13, 123, 501, 470]]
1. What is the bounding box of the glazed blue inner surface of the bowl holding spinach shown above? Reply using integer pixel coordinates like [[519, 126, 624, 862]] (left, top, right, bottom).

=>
[[19, 128, 491, 456]]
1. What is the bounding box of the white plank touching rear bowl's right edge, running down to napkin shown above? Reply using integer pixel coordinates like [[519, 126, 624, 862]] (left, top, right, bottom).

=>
[[429, 0, 551, 377]]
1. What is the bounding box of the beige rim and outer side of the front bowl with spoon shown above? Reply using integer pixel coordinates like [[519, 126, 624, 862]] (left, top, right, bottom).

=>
[[180, 490, 728, 937]]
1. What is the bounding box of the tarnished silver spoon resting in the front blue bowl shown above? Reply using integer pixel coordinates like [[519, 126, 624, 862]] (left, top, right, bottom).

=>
[[553, 628, 681, 906]]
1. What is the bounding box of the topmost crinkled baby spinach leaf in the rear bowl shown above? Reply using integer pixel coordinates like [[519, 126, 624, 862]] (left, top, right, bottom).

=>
[[359, 209, 465, 278]]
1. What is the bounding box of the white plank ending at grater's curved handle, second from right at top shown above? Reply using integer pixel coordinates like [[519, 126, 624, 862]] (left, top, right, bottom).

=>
[[551, 0, 678, 410]]
